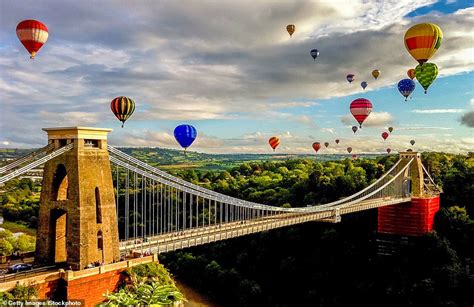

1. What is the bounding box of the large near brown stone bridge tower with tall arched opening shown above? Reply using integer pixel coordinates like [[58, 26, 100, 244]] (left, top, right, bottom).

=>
[[35, 127, 120, 270]]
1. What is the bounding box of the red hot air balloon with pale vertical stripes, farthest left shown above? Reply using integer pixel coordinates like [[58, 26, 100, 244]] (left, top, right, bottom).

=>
[[16, 19, 49, 59]]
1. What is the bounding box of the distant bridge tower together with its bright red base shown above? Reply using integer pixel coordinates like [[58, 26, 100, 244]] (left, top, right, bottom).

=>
[[378, 151, 439, 243]]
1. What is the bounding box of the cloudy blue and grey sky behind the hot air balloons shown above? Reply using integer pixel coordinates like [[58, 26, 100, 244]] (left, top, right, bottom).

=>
[[0, 0, 474, 154]]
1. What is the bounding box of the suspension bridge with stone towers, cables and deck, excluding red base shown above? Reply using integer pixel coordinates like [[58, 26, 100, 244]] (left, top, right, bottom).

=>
[[0, 127, 440, 269]]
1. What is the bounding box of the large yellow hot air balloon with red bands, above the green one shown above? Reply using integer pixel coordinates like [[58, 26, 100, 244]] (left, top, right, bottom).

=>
[[405, 23, 443, 65]]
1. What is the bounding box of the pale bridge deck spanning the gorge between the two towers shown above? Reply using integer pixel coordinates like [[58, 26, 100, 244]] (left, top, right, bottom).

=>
[[119, 197, 411, 255]]
